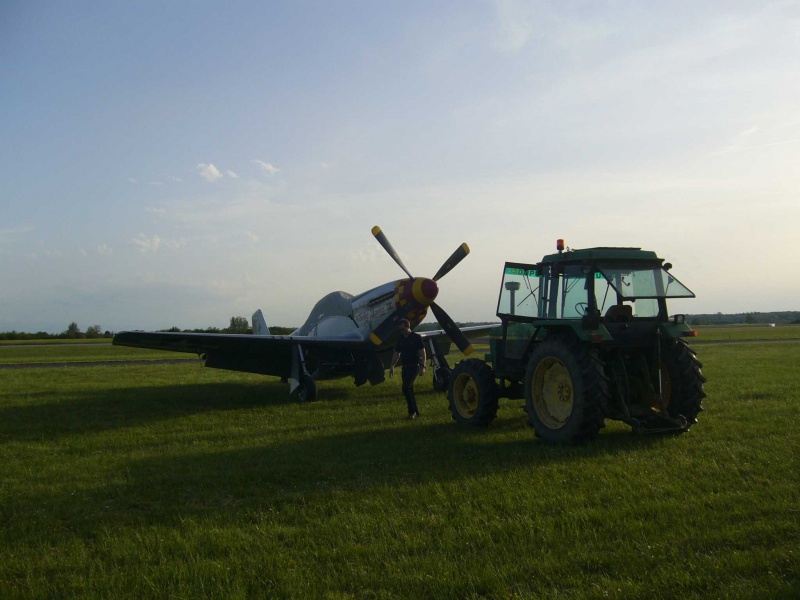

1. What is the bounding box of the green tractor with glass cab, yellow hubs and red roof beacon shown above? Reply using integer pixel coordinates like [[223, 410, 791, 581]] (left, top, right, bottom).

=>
[[448, 240, 705, 444]]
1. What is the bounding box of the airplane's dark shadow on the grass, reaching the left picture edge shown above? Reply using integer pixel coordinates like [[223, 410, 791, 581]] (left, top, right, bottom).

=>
[[0, 381, 294, 441]]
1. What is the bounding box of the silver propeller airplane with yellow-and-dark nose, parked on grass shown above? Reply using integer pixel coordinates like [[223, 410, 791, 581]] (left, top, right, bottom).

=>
[[113, 225, 494, 402]]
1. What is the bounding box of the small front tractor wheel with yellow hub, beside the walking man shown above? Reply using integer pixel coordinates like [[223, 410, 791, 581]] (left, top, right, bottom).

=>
[[447, 358, 498, 426]]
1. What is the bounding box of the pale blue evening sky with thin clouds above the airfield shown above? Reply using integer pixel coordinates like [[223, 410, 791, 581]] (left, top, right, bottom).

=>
[[0, 0, 800, 333]]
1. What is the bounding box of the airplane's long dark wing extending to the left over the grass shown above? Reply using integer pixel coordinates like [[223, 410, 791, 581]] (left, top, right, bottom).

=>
[[113, 331, 371, 377]]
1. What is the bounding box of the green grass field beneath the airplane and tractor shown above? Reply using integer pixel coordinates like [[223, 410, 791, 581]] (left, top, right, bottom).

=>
[[0, 334, 800, 598]]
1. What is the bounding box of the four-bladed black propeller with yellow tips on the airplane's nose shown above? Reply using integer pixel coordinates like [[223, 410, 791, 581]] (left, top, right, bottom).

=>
[[370, 225, 473, 356]]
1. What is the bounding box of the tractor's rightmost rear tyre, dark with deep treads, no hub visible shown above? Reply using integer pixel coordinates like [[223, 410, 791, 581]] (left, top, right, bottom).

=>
[[656, 339, 706, 431]]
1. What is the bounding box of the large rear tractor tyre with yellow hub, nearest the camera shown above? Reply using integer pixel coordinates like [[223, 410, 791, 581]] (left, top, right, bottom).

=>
[[525, 337, 609, 444]]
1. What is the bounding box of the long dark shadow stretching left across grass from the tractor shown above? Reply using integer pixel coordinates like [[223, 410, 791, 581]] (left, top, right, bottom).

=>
[[6, 400, 680, 535]]
